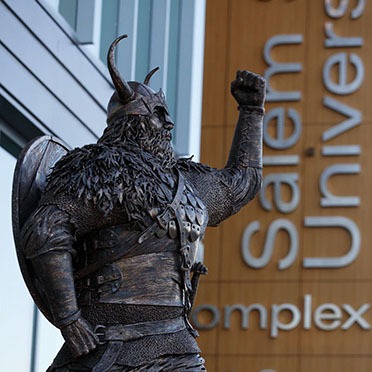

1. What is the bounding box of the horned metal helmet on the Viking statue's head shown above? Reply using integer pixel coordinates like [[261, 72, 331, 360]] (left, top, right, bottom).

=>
[[107, 35, 173, 126]]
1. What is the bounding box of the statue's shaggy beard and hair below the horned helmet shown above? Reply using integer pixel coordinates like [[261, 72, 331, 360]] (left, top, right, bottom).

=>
[[98, 116, 176, 168]]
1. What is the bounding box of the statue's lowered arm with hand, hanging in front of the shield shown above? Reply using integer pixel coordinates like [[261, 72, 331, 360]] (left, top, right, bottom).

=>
[[21, 204, 98, 356]]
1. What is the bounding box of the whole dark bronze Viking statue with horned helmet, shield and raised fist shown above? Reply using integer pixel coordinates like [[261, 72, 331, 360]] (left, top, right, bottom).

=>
[[13, 35, 265, 372]]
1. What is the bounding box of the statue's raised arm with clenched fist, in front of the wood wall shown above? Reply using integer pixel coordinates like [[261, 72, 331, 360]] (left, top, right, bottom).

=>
[[180, 71, 265, 226]]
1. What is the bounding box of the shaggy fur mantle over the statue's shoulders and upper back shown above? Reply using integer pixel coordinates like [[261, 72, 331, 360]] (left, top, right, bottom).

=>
[[46, 143, 171, 216]]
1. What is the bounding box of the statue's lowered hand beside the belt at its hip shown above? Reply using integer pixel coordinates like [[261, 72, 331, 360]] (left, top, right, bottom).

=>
[[61, 318, 99, 358]]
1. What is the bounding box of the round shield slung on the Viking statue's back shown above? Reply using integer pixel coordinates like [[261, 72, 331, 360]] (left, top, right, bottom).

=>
[[12, 135, 69, 322]]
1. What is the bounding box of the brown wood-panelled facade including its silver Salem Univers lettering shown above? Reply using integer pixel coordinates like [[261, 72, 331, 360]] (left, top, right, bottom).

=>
[[194, 0, 372, 372]]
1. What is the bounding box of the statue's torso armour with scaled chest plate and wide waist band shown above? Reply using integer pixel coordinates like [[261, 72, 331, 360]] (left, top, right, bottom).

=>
[[74, 167, 208, 306]]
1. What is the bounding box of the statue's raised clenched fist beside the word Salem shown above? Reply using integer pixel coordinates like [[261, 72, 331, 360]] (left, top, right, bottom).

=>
[[230, 71, 266, 107]]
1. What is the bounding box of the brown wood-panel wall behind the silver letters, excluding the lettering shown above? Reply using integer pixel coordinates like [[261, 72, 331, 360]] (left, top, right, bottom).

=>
[[196, 0, 372, 372]]
